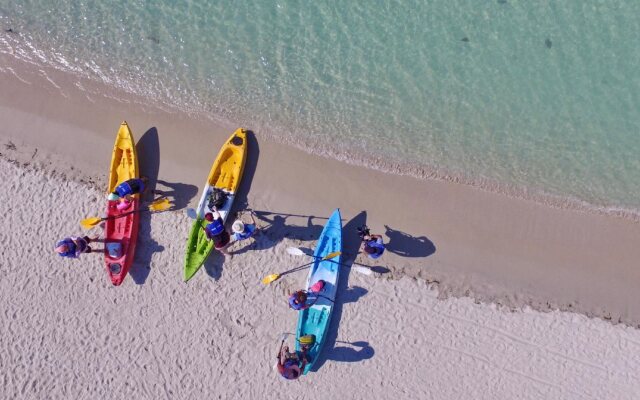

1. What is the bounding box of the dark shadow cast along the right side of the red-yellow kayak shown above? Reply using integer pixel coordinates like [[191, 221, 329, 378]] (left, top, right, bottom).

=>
[[129, 127, 164, 285]]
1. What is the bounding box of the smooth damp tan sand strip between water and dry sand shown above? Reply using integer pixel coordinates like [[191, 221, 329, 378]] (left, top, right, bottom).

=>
[[0, 55, 640, 327]]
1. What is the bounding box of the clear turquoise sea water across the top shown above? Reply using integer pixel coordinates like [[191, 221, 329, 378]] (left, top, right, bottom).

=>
[[0, 0, 640, 217]]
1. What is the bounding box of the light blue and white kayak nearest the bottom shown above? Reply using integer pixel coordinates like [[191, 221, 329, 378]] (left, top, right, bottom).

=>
[[296, 209, 342, 374]]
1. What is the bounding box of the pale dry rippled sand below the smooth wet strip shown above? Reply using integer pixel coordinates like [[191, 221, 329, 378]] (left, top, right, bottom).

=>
[[0, 161, 640, 399]]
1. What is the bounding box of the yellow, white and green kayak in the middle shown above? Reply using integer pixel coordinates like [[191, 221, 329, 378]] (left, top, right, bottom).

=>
[[184, 128, 247, 282]]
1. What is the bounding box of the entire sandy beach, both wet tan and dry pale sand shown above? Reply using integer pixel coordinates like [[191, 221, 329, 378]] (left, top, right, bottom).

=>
[[0, 57, 640, 399]]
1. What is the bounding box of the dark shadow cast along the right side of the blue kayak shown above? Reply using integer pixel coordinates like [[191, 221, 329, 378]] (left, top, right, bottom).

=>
[[312, 211, 373, 372]]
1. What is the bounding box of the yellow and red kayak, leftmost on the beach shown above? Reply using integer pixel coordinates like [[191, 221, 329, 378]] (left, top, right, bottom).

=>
[[104, 121, 140, 286]]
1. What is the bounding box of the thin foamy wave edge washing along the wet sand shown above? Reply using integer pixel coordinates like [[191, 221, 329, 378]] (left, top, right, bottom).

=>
[[0, 35, 640, 222]]
